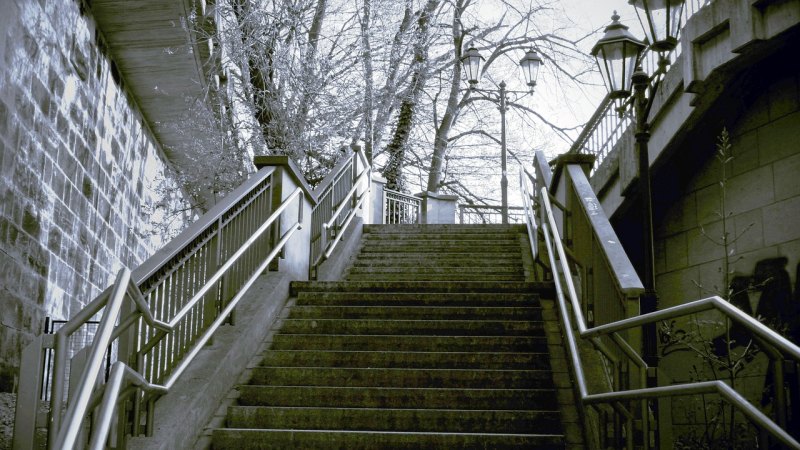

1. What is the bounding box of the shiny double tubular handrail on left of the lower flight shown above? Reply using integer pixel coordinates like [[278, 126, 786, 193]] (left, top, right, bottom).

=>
[[55, 187, 303, 449]]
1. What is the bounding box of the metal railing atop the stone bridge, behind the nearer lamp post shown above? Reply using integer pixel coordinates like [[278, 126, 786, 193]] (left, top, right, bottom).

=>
[[568, 0, 713, 169]]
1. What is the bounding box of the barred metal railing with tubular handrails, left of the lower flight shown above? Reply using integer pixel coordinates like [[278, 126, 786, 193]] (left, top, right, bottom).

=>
[[14, 168, 304, 449]]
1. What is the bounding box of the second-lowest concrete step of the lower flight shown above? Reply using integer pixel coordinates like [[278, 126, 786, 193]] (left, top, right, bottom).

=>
[[228, 406, 560, 433]]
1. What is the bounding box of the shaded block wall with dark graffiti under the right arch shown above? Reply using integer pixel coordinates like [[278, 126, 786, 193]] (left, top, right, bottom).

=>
[[656, 65, 800, 444]]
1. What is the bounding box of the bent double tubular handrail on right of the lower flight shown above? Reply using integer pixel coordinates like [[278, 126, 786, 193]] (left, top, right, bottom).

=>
[[526, 170, 800, 449]]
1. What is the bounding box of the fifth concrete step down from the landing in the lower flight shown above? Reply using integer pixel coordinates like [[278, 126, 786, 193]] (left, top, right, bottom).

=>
[[272, 334, 547, 353]]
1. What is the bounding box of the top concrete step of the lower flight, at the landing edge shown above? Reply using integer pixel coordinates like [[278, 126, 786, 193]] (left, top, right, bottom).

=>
[[290, 281, 553, 295]]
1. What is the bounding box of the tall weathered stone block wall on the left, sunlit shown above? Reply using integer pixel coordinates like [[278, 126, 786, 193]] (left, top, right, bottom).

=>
[[0, 0, 189, 392]]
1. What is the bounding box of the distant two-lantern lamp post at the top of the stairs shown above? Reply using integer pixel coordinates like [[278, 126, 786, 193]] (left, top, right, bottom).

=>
[[461, 47, 542, 224]]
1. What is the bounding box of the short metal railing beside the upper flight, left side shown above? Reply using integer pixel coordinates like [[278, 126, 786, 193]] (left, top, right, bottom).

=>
[[309, 149, 372, 279]]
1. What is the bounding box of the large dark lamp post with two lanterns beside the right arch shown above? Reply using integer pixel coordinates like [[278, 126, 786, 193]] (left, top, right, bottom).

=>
[[592, 0, 685, 366]]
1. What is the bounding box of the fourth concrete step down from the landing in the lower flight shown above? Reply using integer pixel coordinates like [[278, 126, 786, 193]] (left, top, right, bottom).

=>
[[280, 319, 544, 336]]
